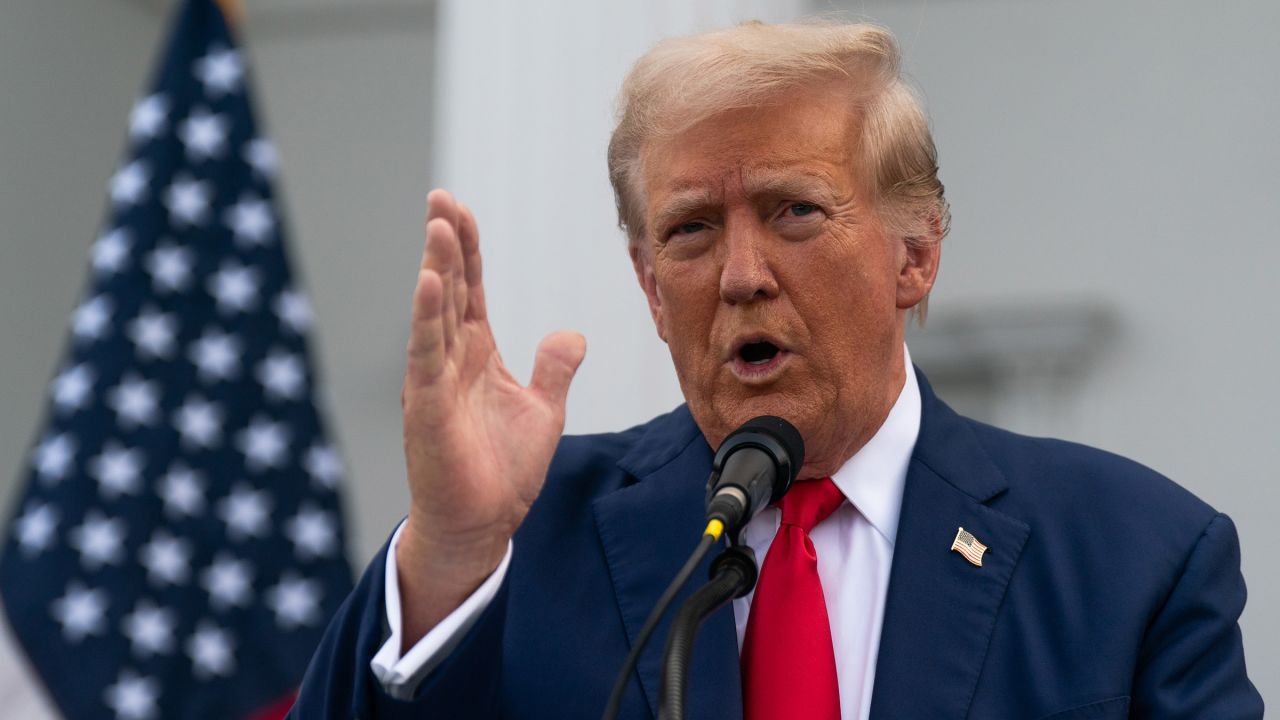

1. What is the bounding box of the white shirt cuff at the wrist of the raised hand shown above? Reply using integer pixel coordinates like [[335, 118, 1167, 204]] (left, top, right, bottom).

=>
[[370, 523, 512, 700]]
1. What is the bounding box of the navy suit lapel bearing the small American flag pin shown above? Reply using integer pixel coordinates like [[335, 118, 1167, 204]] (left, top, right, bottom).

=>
[[870, 373, 1030, 720]]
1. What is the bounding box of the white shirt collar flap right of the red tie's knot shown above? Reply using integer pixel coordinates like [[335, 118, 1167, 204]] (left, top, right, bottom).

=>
[[831, 345, 920, 544]]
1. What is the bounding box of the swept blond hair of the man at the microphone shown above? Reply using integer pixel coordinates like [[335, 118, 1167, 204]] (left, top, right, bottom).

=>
[[609, 22, 950, 252]]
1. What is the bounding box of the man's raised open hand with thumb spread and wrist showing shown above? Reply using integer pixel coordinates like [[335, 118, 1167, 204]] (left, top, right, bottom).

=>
[[396, 190, 586, 640]]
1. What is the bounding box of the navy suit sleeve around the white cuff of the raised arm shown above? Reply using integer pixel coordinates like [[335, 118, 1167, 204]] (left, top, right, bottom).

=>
[[289, 530, 508, 720]]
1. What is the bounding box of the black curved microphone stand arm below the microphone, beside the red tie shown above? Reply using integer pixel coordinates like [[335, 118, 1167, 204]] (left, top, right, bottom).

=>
[[658, 546, 759, 720]]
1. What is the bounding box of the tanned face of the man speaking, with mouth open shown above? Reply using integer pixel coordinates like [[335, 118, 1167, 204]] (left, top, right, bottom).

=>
[[632, 82, 937, 478]]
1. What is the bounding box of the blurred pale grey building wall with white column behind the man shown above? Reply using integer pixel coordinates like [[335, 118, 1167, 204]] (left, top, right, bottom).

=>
[[0, 0, 1280, 702]]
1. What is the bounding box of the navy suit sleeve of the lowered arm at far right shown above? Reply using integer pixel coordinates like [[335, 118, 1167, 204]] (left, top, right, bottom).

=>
[[1132, 514, 1262, 720]]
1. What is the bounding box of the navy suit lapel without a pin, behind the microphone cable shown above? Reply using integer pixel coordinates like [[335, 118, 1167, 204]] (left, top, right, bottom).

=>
[[593, 406, 742, 717]]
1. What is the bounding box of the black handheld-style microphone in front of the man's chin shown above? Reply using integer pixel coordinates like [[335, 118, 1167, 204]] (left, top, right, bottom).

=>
[[707, 415, 804, 541]]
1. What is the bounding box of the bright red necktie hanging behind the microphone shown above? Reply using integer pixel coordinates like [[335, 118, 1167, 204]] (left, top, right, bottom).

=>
[[742, 478, 845, 720]]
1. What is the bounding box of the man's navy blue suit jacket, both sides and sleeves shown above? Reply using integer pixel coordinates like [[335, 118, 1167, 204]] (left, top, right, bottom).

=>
[[293, 375, 1262, 720]]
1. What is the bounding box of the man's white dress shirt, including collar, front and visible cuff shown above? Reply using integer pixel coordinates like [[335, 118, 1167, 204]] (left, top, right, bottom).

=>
[[371, 347, 920, 720]]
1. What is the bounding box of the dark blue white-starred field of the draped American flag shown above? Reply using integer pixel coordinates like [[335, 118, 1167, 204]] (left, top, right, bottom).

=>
[[0, 0, 351, 720]]
